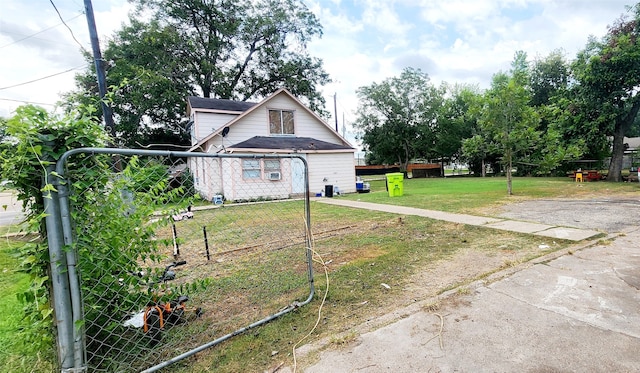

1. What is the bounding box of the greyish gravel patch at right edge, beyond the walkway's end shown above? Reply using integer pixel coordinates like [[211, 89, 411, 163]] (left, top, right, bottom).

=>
[[498, 197, 640, 233]]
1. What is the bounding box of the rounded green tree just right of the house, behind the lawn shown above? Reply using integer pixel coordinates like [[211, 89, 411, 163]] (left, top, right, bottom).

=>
[[354, 68, 442, 170]]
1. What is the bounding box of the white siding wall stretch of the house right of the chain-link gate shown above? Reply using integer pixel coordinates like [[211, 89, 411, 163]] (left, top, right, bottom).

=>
[[307, 152, 356, 195]]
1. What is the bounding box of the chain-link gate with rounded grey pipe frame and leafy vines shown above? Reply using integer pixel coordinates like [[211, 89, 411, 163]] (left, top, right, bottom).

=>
[[43, 148, 314, 372]]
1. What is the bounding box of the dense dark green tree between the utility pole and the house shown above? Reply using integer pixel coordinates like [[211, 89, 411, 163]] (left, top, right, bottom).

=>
[[67, 19, 195, 147]]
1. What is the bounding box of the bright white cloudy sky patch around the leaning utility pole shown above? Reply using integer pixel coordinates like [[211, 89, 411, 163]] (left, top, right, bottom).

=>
[[0, 0, 131, 117]]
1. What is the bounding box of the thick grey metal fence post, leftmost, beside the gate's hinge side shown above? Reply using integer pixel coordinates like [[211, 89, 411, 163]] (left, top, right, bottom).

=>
[[42, 163, 74, 372]]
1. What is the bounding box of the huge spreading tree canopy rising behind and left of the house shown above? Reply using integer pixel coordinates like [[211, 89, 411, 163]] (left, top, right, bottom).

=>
[[68, 0, 329, 146]]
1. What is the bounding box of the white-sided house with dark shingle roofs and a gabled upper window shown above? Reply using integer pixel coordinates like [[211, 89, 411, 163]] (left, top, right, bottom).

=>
[[187, 89, 356, 201]]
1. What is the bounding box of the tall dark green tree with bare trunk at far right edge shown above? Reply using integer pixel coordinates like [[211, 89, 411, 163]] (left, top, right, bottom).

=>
[[565, 3, 640, 181]]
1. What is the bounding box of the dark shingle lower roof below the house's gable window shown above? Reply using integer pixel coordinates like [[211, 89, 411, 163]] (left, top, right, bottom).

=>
[[230, 136, 353, 151]]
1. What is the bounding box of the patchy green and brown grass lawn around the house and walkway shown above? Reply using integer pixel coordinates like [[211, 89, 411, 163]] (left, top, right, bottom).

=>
[[0, 177, 640, 372]]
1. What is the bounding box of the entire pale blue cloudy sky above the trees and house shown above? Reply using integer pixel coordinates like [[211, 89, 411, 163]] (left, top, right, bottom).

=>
[[0, 0, 633, 139]]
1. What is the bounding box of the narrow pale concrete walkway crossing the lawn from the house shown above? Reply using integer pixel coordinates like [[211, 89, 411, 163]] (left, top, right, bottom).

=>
[[312, 198, 602, 241]]
